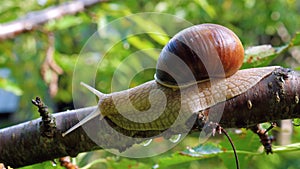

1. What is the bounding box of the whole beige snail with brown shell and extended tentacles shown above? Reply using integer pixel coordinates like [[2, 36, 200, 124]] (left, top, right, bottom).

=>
[[62, 24, 276, 136]]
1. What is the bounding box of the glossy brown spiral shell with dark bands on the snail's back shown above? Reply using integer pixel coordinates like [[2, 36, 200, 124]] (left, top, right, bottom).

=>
[[155, 24, 244, 87]]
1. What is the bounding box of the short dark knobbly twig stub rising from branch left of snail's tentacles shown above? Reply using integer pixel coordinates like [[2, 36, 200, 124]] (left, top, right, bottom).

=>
[[31, 97, 56, 138]]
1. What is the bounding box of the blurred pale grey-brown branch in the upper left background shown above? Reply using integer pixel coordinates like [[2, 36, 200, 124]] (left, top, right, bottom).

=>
[[0, 0, 107, 40]]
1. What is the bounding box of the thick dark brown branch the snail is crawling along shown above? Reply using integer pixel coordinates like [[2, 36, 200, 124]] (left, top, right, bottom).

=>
[[0, 68, 300, 167]]
